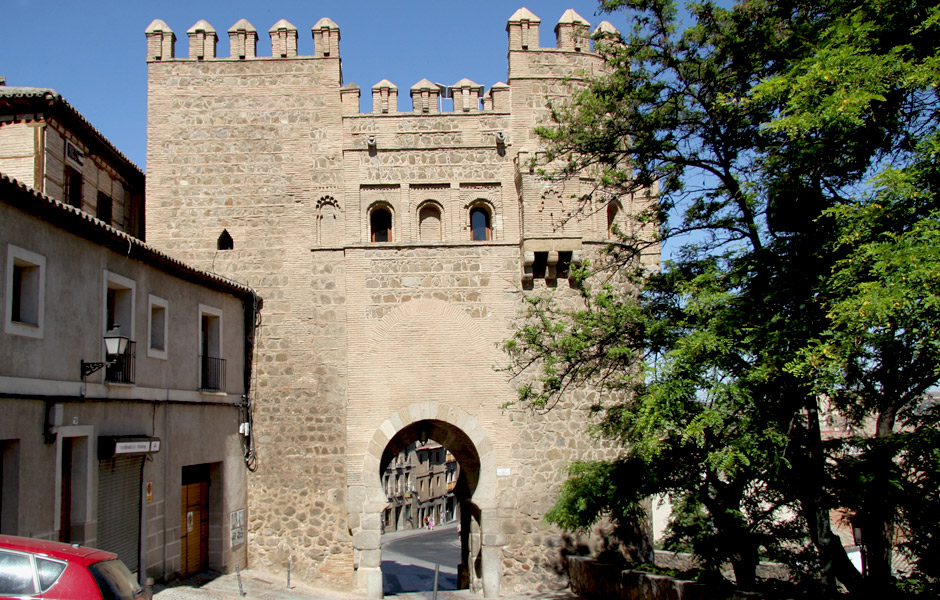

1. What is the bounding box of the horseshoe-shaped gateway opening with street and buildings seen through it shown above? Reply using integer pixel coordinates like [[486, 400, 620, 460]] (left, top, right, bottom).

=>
[[380, 419, 482, 595]]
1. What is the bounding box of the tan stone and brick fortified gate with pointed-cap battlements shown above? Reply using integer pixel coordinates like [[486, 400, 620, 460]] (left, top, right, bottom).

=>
[[146, 9, 658, 598]]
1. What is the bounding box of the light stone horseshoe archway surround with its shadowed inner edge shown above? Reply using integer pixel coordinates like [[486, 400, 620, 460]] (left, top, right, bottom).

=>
[[349, 402, 501, 598]]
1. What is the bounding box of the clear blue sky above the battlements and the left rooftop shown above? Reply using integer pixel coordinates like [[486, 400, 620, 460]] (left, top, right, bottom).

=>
[[0, 0, 608, 169]]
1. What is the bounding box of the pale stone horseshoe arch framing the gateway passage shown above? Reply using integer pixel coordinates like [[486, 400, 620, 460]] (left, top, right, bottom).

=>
[[347, 402, 501, 598]]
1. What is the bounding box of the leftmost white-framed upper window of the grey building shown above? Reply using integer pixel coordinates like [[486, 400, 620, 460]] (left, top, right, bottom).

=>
[[5, 244, 46, 338]]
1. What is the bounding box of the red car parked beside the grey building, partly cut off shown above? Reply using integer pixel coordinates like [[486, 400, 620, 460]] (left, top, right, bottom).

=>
[[0, 535, 144, 600]]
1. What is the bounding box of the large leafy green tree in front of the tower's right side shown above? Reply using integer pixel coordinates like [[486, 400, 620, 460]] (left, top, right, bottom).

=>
[[506, 0, 940, 596]]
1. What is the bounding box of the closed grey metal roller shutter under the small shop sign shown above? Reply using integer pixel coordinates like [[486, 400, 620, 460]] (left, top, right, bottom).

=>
[[96, 456, 144, 573]]
